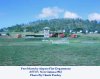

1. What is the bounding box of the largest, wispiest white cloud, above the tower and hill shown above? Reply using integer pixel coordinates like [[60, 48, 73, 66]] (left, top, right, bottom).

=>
[[38, 7, 63, 18]]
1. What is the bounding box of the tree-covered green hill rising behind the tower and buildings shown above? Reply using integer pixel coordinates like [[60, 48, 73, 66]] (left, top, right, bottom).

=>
[[0, 18, 100, 33]]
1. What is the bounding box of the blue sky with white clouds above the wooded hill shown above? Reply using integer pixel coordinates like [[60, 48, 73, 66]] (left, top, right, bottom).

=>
[[0, 0, 100, 28]]
